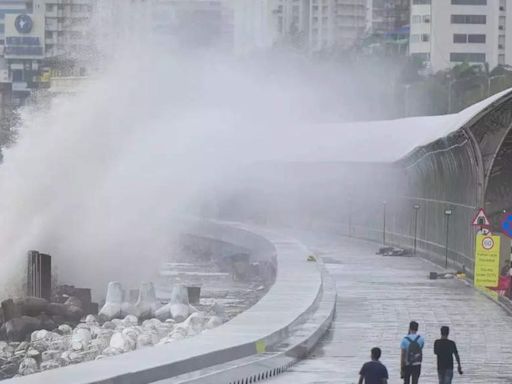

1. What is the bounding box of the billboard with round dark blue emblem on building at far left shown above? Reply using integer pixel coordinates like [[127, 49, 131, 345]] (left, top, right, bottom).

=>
[[4, 14, 45, 59]]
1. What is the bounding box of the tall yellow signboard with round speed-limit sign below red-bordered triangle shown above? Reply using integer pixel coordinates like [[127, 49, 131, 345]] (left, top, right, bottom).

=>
[[475, 235, 500, 288]]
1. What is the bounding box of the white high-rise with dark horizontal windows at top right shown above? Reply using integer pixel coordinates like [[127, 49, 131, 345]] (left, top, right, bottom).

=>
[[410, 0, 512, 71]]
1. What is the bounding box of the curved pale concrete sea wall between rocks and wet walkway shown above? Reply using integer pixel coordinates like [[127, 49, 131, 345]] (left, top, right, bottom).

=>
[[7, 221, 335, 384]]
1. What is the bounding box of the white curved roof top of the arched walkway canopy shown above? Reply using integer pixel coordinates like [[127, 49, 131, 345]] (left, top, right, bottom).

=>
[[276, 89, 512, 162]]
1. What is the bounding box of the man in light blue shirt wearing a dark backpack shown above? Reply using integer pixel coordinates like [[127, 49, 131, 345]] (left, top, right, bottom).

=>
[[400, 321, 425, 384]]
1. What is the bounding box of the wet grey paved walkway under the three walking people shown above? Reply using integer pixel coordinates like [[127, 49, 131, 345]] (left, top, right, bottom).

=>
[[269, 235, 512, 384]]
